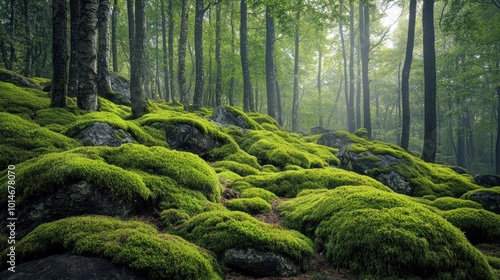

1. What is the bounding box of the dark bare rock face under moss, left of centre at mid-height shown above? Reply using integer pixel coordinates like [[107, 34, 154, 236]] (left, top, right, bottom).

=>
[[165, 124, 222, 157]]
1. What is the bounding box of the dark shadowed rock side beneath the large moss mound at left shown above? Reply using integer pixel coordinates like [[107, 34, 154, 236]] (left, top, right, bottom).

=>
[[0, 181, 139, 238]]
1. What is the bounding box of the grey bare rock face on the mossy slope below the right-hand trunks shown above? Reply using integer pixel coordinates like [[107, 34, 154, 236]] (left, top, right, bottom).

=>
[[336, 147, 414, 195]]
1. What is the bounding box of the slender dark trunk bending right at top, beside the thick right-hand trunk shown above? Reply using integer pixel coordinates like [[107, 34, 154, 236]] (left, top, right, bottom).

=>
[[401, 0, 417, 151]]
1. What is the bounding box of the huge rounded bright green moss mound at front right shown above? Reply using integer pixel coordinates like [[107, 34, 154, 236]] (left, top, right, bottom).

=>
[[278, 187, 494, 279]]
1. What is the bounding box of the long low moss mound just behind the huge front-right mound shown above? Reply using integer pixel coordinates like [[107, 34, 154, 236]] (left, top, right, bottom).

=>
[[231, 168, 391, 197]]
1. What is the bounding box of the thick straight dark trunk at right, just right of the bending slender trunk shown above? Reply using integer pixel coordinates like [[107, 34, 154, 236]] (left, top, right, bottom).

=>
[[421, 0, 437, 162]]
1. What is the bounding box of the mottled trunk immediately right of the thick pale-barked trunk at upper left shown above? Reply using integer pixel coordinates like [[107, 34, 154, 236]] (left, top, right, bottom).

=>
[[97, 0, 111, 94]]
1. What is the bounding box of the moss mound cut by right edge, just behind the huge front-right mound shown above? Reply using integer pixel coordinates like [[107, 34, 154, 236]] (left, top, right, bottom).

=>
[[441, 208, 500, 244]]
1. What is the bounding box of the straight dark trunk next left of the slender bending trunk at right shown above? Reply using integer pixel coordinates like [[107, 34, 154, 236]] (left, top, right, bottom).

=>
[[360, 4, 372, 139]]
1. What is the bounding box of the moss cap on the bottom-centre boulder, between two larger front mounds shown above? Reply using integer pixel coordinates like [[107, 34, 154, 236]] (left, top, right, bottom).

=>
[[179, 211, 314, 266]]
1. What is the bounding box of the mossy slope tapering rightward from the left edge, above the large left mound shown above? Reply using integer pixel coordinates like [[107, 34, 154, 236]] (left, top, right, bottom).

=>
[[0, 112, 80, 170]]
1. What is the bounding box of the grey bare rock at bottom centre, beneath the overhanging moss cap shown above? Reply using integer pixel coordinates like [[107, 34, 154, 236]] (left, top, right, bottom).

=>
[[224, 248, 300, 276]]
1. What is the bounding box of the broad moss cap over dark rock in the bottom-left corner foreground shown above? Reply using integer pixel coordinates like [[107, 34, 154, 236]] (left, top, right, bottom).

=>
[[1, 216, 222, 280]]
